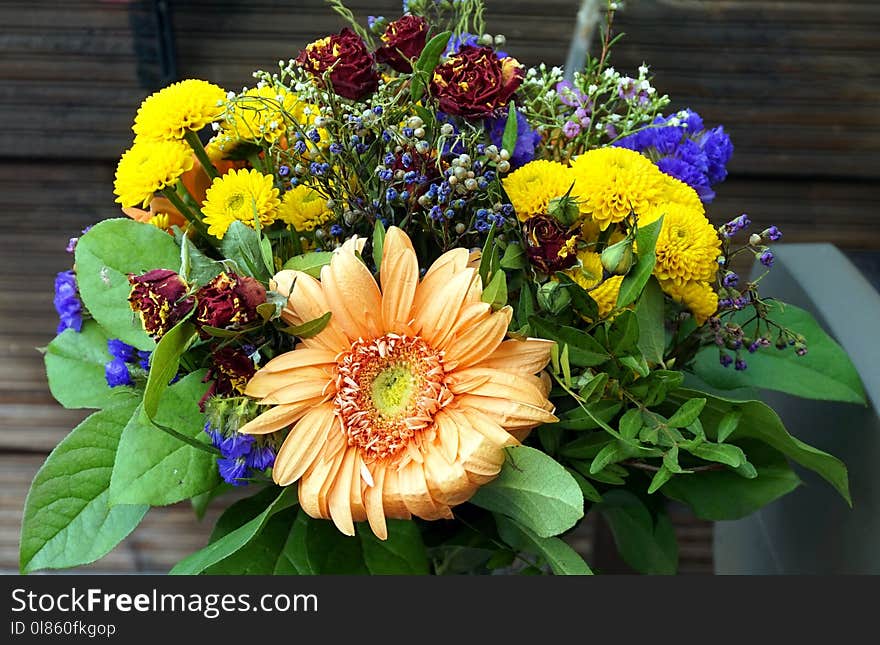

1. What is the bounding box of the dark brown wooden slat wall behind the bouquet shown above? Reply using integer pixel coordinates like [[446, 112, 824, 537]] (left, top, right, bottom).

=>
[[0, 0, 880, 573]]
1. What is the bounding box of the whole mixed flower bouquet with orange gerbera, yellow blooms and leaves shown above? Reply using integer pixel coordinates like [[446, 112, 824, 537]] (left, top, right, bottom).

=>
[[21, 0, 864, 574]]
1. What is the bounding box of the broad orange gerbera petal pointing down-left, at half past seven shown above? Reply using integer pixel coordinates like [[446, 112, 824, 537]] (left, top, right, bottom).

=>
[[272, 403, 342, 486]]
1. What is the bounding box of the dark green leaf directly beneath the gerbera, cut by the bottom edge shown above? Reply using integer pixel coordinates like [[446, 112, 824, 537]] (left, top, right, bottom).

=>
[[357, 520, 429, 576]]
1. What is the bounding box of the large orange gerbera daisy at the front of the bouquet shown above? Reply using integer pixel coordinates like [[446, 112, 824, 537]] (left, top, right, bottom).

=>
[[241, 228, 556, 539]]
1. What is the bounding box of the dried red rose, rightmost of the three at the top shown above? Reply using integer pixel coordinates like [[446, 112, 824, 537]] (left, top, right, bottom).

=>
[[431, 45, 524, 119]]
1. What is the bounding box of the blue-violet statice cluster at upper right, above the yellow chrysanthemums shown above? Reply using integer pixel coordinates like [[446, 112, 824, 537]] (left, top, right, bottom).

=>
[[614, 110, 733, 203]]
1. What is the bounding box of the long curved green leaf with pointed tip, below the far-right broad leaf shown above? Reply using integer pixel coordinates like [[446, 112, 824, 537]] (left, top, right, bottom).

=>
[[664, 389, 852, 504]]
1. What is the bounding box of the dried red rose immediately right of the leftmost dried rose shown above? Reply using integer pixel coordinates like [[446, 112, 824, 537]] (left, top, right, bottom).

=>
[[195, 273, 266, 338]]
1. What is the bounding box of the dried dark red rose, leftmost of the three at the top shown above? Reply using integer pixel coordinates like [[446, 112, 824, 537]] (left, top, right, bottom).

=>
[[296, 27, 379, 101]]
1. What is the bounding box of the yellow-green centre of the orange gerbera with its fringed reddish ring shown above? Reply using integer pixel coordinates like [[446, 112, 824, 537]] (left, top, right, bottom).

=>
[[334, 334, 452, 461]]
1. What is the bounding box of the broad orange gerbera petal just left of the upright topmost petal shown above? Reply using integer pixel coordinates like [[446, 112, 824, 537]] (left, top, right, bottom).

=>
[[321, 252, 383, 341]]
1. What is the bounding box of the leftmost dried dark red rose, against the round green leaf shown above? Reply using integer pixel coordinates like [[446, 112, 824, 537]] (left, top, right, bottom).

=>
[[128, 269, 195, 340]]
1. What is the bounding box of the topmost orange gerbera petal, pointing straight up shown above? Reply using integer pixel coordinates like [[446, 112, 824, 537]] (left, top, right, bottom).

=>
[[379, 226, 419, 333]]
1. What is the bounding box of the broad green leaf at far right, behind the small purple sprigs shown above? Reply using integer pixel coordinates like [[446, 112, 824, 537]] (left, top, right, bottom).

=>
[[693, 303, 865, 405]]
